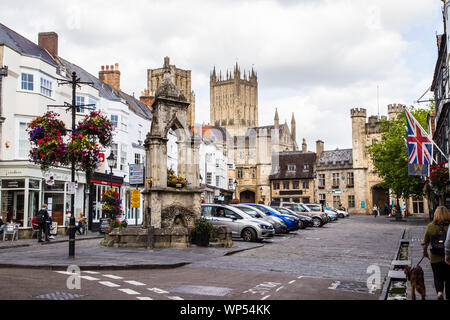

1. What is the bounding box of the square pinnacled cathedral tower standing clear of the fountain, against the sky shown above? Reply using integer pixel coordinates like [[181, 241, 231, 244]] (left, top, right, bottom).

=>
[[210, 63, 258, 136]]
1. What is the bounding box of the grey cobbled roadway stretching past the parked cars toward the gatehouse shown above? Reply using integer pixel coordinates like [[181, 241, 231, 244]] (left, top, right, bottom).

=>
[[189, 216, 426, 282]]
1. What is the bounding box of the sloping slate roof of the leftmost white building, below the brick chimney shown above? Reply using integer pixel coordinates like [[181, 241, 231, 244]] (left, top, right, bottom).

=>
[[0, 23, 58, 67]]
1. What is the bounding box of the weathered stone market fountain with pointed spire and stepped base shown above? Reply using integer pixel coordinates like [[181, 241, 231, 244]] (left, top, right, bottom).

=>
[[103, 67, 202, 248]]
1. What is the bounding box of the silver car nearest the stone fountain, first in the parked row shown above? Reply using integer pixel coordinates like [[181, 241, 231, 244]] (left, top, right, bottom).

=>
[[202, 204, 275, 241]]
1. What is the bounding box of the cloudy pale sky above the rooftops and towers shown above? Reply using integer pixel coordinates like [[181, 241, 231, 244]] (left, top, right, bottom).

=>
[[0, 0, 442, 151]]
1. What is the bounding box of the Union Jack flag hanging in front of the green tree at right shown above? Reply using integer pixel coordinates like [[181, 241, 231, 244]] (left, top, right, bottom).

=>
[[405, 110, 433, 166]]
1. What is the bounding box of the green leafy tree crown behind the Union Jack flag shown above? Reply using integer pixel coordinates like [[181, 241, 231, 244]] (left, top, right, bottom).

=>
[[368, 105, 434, 198]]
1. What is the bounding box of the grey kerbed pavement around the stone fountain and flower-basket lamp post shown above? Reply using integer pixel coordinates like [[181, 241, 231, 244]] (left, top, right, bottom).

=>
[[0, 234, 262, 270]]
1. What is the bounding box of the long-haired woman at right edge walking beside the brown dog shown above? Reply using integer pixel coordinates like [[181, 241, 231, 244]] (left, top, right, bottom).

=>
[[422, 206, 450, 300]]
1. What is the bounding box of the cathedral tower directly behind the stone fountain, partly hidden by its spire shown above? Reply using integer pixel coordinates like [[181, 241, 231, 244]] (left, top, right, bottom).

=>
[[147, 57, 195, 127]]
